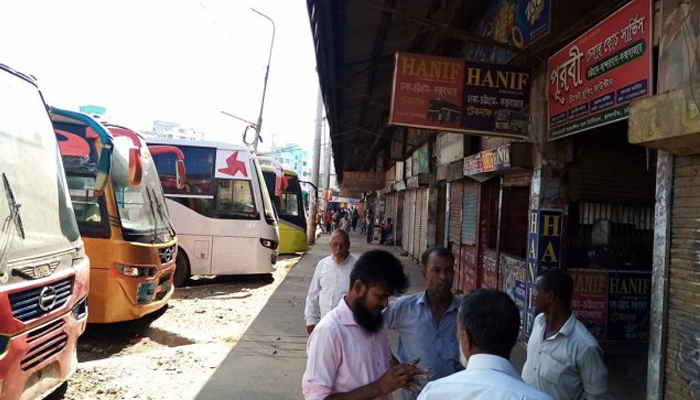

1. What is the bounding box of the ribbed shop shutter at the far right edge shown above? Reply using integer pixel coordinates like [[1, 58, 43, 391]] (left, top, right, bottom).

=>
[[664, 155, 700, 400]]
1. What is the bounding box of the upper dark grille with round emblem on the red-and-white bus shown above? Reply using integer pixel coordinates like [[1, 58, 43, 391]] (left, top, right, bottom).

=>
[[9, 278, 73, 322]]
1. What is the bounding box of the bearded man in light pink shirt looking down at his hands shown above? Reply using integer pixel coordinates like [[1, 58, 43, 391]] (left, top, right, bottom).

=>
[[301, 250, 424, 400]]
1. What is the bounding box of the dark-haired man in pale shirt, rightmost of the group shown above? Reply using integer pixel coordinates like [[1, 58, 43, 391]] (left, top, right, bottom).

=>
[[523, 269, 608, 400]]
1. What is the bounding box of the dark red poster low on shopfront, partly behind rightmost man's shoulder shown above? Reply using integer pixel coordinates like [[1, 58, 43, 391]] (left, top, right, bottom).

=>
[[568, 270, 608, 342]]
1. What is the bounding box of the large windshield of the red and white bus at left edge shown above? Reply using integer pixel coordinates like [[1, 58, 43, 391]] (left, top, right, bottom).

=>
[[0, 69, 80, 284]]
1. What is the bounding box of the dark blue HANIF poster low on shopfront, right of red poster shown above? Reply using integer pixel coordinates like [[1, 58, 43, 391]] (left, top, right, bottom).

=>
[[607, 272, 651, 341]]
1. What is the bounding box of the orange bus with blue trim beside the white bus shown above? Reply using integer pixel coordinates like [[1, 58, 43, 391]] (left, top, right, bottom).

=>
[[51, 108, 177, 323]]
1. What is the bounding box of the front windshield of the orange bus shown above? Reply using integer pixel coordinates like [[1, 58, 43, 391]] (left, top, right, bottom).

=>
[[112, 137, 175, 243]]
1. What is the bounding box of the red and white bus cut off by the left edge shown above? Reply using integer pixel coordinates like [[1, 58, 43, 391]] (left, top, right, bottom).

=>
[[0, 65, 90, 400]]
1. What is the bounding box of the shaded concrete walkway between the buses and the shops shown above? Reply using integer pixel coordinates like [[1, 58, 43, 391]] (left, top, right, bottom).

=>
[[197, 230, 425, 400]]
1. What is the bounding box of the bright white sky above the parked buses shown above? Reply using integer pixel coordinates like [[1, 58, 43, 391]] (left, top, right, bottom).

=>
[[0, 0, 318, 150]]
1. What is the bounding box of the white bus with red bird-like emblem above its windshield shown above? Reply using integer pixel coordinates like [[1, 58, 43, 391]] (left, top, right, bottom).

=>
[[148, 138, 279, 286]]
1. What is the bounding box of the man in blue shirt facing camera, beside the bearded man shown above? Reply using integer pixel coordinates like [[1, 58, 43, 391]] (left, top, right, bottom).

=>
[[384, 247, 464, 400]]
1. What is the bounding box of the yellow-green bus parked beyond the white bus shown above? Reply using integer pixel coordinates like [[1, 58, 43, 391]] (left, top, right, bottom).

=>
[[258, 157, 306, 254]]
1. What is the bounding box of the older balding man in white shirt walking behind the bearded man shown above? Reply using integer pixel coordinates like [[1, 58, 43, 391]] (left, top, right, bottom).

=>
[[304, 229, 357, 335]]
